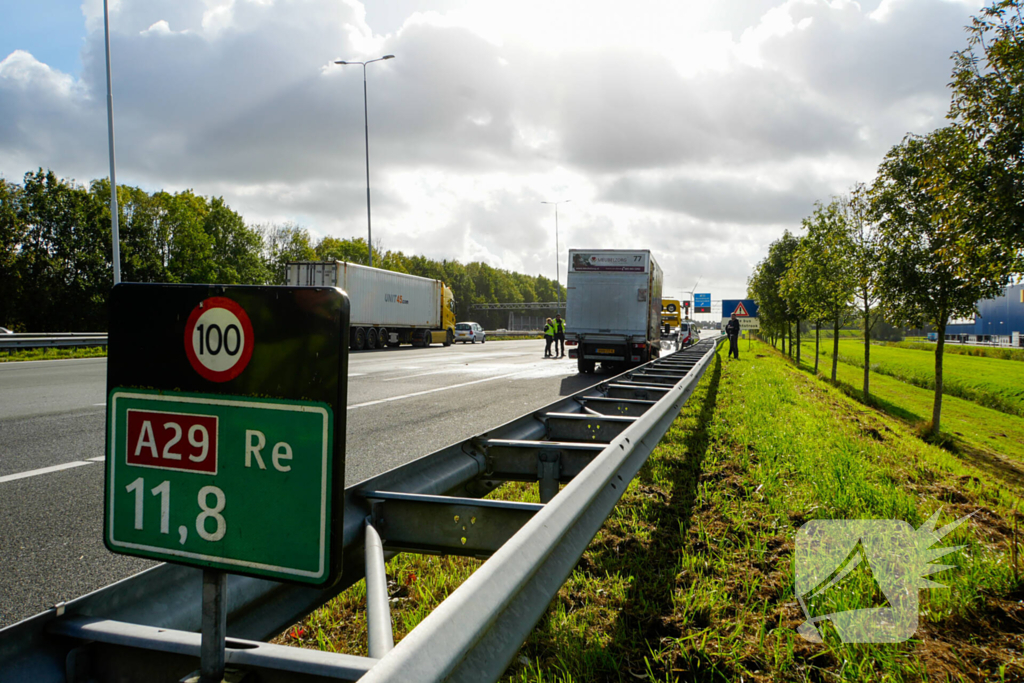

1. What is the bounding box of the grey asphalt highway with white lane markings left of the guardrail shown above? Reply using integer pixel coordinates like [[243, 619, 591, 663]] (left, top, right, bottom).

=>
[[0, 340, 602, 628]]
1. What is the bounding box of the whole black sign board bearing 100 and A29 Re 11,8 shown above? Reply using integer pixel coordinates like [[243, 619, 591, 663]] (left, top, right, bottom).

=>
[[103, 284, 349, 586]]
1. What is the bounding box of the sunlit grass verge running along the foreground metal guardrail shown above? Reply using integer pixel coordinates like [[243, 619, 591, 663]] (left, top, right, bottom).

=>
[[282, 344, 1024, 683]]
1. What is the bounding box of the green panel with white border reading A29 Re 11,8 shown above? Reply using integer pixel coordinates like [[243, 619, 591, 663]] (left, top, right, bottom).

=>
[[106, 389, 333, 584]]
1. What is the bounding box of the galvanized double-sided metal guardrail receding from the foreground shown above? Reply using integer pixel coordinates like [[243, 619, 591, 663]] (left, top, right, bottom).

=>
[[0, 337, 723, 683]]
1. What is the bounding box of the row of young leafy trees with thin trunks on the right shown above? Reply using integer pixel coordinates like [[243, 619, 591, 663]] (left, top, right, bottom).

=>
[[748, 0, 1024, 433]]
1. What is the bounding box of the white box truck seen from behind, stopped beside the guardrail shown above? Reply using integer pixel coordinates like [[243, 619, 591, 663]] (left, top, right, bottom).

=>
[[565, 249, 664, 373]]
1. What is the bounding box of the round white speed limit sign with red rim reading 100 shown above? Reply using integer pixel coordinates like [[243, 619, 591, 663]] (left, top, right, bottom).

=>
[[184, 297, 255, 382]]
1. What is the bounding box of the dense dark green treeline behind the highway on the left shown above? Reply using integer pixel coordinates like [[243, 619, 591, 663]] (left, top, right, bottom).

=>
[[0, 169, 564, 332]]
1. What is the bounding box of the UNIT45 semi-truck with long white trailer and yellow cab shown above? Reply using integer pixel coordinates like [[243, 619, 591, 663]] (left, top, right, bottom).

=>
[[285, 261, 455, 351]]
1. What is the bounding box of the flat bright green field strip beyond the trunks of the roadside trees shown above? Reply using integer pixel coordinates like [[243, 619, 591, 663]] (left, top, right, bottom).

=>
[[802, 339, 1024, 416]]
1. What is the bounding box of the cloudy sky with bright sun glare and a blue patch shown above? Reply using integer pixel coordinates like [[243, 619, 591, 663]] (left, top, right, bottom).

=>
[[0, 0, 981, 299]]
